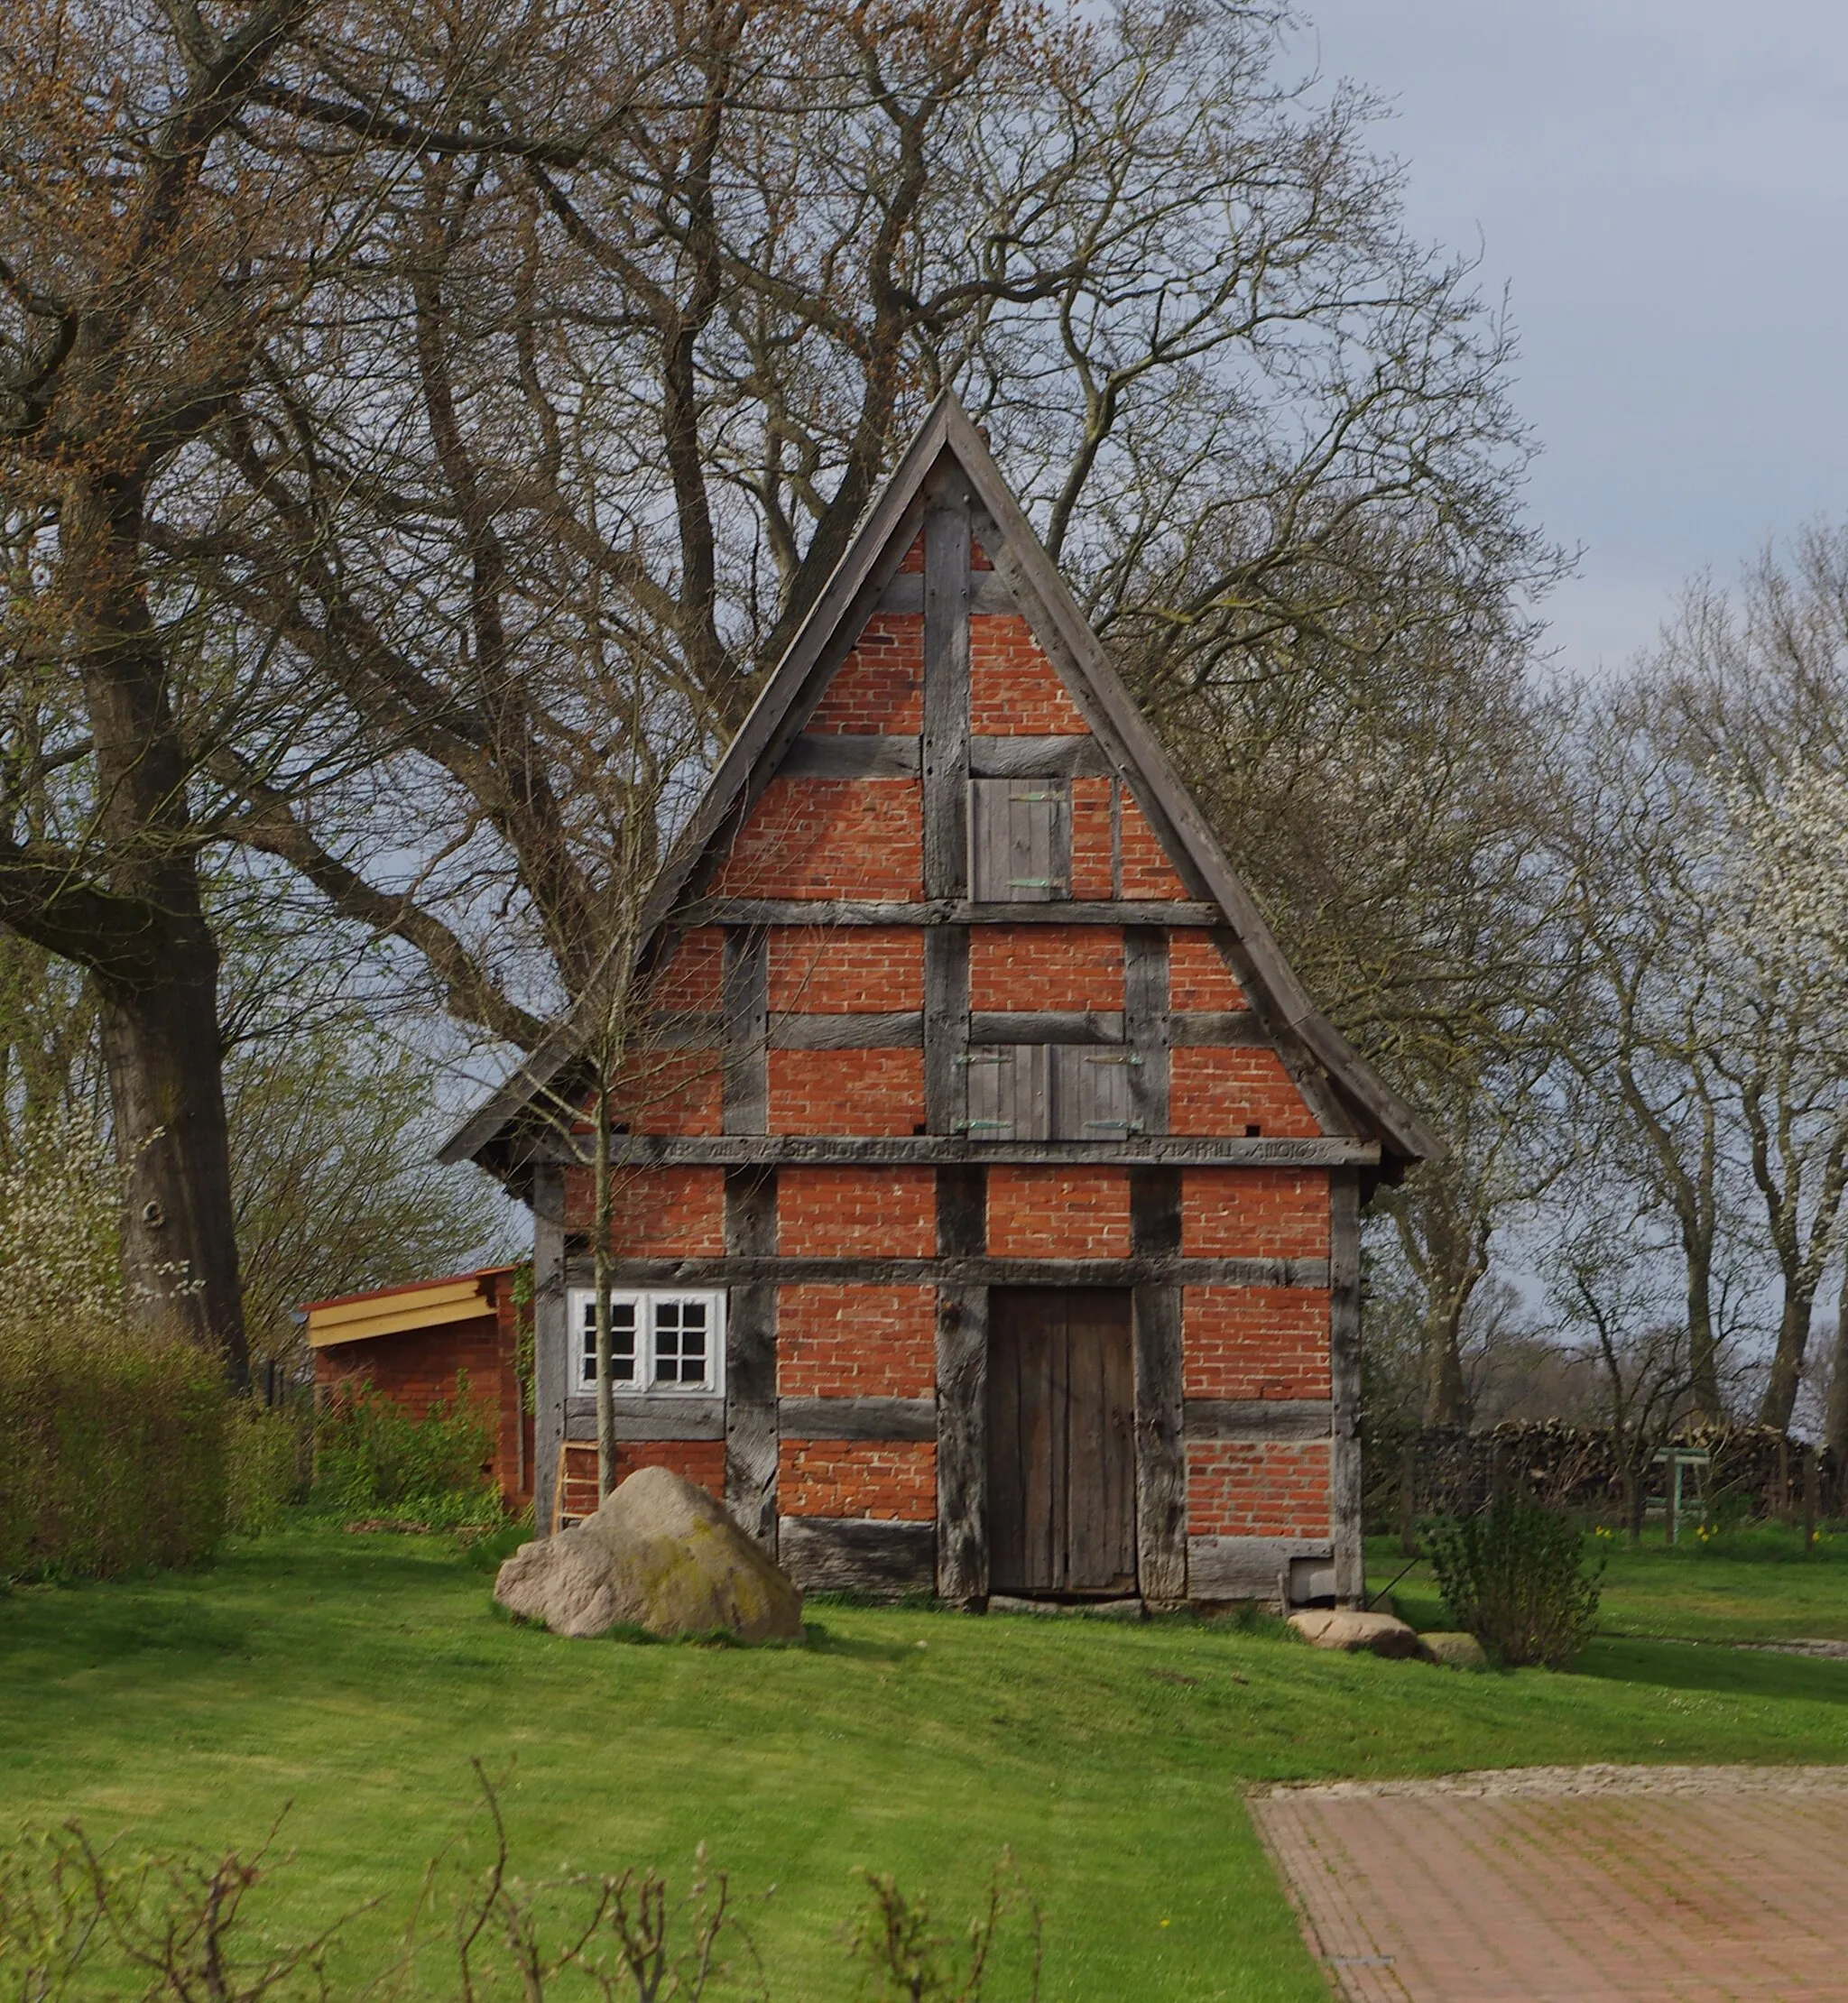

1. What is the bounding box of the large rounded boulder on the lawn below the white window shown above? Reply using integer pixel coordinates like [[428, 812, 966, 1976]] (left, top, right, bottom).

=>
[[494, 1468, 803, 1640]]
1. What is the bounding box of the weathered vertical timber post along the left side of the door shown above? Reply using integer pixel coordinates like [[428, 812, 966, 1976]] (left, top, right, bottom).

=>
[[937, 1168, 989, 1606]]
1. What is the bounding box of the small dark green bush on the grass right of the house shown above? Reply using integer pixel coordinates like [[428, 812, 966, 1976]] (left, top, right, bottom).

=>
[[1428, 1491, 1603, 1668]]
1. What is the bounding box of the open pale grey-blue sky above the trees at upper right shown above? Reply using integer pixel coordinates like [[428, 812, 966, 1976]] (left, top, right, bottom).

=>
[[1306, 0, 1848, 669]]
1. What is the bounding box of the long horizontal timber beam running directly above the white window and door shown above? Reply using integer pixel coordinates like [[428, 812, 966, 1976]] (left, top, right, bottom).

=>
[[567, 1252, 1327, 1288]]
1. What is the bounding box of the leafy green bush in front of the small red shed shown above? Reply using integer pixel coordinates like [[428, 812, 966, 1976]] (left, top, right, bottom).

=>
[[312, 1370, 501, 1524]]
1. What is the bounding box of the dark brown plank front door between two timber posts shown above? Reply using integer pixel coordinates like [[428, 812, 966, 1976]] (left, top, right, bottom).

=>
[[989, 1288, 1135, 1599]]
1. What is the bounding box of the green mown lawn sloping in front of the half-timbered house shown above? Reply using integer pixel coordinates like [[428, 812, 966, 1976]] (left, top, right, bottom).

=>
[[0, 1528, 1848, 2003]]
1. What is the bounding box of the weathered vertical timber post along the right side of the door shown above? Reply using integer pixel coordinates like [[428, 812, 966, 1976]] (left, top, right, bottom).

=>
[[1129, 1168, 1187, 1606]]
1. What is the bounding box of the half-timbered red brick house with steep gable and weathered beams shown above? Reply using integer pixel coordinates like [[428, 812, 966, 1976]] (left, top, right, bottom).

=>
[[447, 399, 1436, 1604]]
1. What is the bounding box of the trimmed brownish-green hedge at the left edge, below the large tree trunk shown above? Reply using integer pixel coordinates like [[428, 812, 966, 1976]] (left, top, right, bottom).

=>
[[0, 1316, 226, 1578]]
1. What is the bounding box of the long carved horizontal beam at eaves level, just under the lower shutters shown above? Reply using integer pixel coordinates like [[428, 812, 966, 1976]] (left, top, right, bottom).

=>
[[527, 1134, 1380, 1168]]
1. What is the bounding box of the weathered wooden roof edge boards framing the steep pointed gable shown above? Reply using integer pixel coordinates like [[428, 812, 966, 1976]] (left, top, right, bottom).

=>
[[439, 392, 1444, 1176]]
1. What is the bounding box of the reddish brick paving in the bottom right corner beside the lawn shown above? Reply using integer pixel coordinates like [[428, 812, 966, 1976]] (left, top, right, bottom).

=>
[[1252, 1767, 1848, 2003]]
